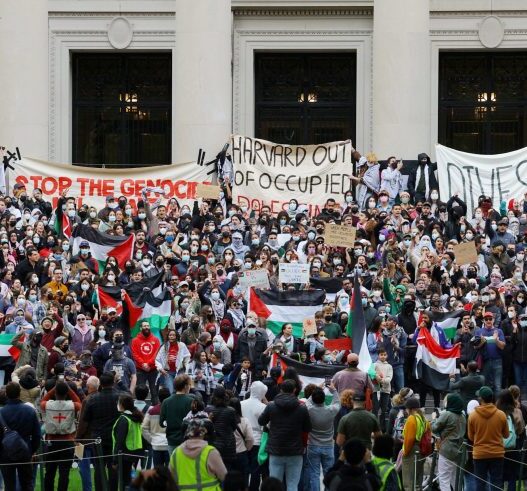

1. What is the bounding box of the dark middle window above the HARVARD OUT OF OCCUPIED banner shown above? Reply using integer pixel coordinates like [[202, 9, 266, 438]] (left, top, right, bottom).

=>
[[255, 53, 357, 145]]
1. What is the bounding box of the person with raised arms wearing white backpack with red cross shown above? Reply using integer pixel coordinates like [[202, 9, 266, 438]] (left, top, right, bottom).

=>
[[40, 375, 81, 491]]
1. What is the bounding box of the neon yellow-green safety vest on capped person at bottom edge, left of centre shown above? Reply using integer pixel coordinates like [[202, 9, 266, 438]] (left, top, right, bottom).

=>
[[170, 445, 221, 491]]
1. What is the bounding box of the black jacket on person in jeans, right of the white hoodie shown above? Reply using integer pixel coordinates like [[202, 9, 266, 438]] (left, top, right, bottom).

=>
[[258, 392, 311, 456]]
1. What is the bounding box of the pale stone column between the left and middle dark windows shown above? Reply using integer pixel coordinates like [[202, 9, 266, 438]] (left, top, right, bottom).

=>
[[173, 0, 232, 163]]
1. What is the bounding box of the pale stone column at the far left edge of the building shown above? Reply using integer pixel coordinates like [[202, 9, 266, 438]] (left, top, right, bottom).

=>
[[0, 0, 49, 160]]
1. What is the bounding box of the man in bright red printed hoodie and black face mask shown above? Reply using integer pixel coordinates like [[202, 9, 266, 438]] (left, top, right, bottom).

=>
[[131, 320, 161, 404]]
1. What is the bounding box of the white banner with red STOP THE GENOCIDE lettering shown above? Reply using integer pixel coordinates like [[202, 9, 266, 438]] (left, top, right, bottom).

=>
[[10, 158, 208, 209]]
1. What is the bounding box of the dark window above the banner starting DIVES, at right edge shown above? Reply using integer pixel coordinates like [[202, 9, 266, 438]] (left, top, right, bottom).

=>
[[439, 52, 527, 154]]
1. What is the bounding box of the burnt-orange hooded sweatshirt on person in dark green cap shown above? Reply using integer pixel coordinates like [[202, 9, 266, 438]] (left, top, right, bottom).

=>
[[468, 404, 509, 460]]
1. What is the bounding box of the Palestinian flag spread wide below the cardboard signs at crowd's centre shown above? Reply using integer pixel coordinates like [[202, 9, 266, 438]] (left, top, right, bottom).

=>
[[248, 288, 326, 338]]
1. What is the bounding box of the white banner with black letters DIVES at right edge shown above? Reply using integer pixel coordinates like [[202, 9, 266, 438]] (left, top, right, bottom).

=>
[[436, 145, 527, 210]]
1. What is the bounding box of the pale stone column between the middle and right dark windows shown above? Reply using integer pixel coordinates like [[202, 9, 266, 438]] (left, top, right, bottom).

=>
[[374, 0, 437, 159]]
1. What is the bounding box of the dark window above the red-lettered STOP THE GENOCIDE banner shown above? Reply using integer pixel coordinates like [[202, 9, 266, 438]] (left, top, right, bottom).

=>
[[72, 53, 172, 167]]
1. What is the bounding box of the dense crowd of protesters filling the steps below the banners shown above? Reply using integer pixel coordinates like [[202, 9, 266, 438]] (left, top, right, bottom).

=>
[[0, 154, 527, 491]]
